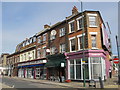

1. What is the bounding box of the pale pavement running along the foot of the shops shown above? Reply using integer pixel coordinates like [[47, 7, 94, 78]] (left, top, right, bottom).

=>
[[0, 73, 118, 89]]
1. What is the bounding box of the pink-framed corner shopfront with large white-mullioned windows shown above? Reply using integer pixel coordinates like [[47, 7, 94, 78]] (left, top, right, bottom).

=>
[[66, 50, 109, 81]]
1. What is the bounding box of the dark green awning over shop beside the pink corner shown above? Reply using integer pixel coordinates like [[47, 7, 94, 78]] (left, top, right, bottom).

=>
[[45, 54, 66, 67]]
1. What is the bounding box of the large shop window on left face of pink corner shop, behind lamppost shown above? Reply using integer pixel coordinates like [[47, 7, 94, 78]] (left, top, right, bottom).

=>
[[70, 58, 89, 80]]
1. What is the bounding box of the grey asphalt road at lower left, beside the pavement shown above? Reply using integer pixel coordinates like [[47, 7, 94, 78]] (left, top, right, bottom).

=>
[[2, 77, 65, 88]]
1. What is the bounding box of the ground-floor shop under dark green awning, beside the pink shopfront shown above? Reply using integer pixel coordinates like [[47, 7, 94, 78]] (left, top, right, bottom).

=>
[[45, 54, 66, 81]]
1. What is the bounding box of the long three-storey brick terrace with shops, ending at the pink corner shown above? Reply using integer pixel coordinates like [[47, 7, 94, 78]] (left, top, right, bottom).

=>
[[8, 6, 111, 80]]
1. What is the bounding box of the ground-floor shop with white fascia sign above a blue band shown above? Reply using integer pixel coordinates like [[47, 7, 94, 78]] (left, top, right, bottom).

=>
[[18, 60, 46, 79]]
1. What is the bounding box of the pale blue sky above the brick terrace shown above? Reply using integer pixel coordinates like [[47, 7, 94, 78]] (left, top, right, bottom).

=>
[[0, 2, 118, 54]]
